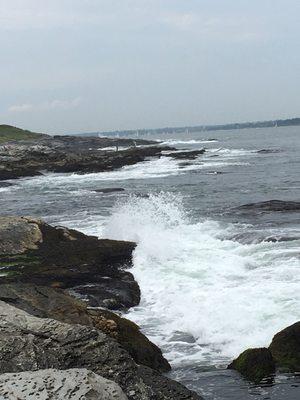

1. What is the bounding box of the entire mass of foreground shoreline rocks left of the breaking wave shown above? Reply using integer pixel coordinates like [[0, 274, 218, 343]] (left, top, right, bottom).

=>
[[0, 217, 200, 400]]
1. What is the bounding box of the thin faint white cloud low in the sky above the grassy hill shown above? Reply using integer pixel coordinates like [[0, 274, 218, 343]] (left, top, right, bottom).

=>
[[8, 97, 82, 113]]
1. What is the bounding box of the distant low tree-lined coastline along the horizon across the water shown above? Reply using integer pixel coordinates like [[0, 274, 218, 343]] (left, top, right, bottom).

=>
[[76, 118, 300, 137]]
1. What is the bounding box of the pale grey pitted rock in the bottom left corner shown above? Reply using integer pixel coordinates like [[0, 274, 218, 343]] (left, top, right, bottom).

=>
[[0, 368, 127, 400]]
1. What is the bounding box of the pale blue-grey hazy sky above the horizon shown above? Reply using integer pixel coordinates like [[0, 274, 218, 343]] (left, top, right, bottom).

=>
[[0, 0, 300, 134]]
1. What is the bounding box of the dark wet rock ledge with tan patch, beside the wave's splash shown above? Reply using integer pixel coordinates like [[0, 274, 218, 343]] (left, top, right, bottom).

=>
[[0, 217, 140, 309]]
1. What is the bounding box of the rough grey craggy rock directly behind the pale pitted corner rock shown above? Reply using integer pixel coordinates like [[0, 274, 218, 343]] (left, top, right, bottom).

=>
[[0, 301, 200, 400]]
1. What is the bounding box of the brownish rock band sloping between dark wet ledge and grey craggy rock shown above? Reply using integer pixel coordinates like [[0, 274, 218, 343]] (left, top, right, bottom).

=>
[[0, 283, 170, 372]]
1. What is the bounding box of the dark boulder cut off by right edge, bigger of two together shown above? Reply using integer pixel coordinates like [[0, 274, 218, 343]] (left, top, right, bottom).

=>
[[269, 322, 300, 372]]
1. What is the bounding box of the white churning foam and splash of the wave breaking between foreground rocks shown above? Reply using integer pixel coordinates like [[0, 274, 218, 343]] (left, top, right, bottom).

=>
[[104, 193, 300, 365]]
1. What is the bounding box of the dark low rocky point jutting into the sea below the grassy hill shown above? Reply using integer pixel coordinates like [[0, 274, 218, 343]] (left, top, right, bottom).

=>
[[0, 136, 172, 180]]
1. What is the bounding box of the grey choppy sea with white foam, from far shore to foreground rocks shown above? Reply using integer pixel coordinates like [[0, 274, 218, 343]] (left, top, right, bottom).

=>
[[0, 128, 300, 400]]
